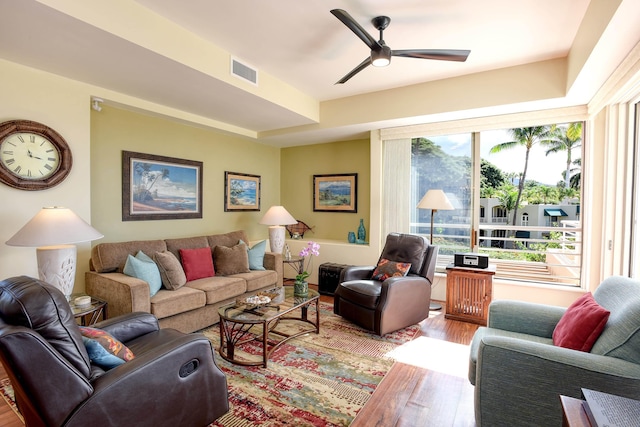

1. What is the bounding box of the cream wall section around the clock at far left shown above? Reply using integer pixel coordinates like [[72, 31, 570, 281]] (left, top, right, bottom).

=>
[[0, 60, 91, 290]]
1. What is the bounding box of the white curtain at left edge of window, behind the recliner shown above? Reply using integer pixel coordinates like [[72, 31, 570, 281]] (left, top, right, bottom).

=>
[[382, 138, 415, 239]]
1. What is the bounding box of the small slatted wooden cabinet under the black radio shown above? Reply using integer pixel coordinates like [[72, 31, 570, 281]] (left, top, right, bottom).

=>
[[444, 264, 496, 326]]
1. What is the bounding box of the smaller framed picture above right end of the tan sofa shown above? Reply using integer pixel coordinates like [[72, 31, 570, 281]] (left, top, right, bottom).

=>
[[224, 171, 261, 212]]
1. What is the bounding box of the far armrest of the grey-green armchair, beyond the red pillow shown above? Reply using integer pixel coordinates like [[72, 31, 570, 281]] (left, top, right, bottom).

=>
[[487, 300, 566, 338]]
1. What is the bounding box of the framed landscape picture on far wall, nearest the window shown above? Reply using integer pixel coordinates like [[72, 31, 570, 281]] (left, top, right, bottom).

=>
[[313, 173, 358, 213]]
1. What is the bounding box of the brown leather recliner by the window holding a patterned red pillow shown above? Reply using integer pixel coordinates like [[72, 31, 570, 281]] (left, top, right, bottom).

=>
[[333, 233, 438, 335]]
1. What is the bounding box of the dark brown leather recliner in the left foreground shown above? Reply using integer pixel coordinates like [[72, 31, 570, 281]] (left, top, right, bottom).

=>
[[0, 276, 229, 427]]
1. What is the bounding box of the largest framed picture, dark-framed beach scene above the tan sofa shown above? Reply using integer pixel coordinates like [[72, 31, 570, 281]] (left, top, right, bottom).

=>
[[122, 151, 202, 221]]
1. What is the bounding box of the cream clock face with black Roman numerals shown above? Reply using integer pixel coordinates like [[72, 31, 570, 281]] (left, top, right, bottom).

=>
[[0, 132, 60, 180]]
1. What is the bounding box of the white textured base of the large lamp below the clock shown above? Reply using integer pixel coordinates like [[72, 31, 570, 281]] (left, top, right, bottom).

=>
[[36, 245, 78, 300]]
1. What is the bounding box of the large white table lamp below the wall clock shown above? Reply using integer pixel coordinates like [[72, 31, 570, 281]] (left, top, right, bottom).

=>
[[6, 206, 104, 300]]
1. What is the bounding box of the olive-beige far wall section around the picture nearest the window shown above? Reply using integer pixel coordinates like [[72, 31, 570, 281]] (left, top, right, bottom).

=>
[[280, 140, 371, 243]]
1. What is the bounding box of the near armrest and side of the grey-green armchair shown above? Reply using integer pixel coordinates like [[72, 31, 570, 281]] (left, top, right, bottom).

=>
[[475, 336, 640, 425]]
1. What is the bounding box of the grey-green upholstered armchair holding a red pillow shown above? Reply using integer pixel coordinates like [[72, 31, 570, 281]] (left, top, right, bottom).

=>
[[469, 277, 640, 427]]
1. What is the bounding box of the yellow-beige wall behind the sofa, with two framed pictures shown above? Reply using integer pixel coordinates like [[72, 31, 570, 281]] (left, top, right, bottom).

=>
[[91, 105, 280, 242]]
